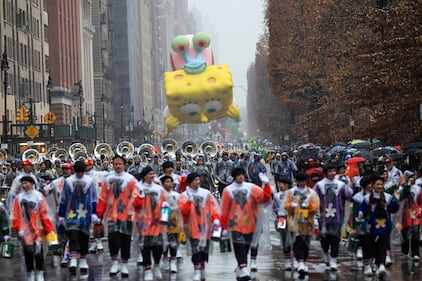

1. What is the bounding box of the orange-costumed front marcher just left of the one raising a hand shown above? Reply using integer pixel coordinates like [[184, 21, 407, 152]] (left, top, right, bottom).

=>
[[179, 173, 221, 281]]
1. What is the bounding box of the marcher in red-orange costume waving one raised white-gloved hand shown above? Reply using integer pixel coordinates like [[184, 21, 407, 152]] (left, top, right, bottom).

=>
[[221, 168, 272, 281]]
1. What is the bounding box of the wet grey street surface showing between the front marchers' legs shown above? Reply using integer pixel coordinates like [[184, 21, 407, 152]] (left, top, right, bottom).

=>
[[0, 230, 422, 281]]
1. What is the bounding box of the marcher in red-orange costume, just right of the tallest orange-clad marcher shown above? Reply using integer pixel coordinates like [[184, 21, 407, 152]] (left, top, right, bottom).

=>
[[133, 166, 170, 281]]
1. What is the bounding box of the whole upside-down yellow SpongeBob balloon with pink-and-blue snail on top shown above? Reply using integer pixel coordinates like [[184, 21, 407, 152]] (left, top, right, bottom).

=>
[[164, 32, 240, 132]]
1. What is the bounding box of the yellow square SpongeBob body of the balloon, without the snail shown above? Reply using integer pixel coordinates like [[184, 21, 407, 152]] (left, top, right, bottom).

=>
[[164, 64, 240, 132]]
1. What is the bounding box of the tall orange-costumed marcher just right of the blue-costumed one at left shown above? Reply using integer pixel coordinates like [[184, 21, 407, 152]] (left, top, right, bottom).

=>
[[94, 155, 138, 277]]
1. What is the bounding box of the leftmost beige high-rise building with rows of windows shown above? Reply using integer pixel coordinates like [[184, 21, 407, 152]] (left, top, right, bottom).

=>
[[0, 0, 49, 147]]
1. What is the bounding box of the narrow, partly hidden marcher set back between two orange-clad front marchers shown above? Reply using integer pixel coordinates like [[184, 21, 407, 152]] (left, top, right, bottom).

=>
[[160, 176, 181, 273]]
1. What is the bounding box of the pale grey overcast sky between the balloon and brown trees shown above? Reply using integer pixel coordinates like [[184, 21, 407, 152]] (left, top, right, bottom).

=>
[[189, 0, 264, 107]]
